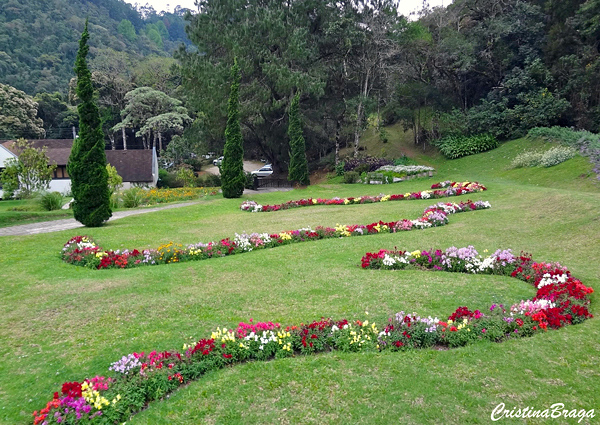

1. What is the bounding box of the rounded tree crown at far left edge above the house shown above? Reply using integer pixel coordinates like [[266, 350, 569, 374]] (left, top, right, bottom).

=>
[[0, 84, 44, 139]]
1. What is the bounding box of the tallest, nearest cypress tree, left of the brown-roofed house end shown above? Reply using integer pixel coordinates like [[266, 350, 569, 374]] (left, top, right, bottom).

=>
[[67, 20, 112, 227]]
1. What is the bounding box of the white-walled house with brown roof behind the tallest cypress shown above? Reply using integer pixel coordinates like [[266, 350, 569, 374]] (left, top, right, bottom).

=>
[[0, 139, 158, 196]]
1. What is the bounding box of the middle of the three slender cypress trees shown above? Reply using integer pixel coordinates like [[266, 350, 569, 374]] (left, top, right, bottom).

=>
[[221, 59, 246, 198]]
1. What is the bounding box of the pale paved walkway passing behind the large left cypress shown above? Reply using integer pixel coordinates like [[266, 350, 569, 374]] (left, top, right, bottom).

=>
[[0, 202, 198, 236]]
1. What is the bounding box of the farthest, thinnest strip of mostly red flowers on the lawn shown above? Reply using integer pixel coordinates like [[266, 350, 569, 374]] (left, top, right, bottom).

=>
[[240, 181, 487, 212]]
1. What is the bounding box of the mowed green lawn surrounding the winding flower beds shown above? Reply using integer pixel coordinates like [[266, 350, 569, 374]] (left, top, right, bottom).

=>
[[0, 142, 600, 424]]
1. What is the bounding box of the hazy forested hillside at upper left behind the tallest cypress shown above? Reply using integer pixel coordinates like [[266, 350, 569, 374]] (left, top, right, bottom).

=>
[[0, 0, 189, 95]]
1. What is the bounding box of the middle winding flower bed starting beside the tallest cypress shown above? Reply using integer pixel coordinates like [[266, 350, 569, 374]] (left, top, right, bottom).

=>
[[61, 200, 491, 269]]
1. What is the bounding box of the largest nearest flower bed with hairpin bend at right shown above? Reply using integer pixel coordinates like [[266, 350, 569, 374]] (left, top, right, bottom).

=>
[[33, 246, 593, 424]]
